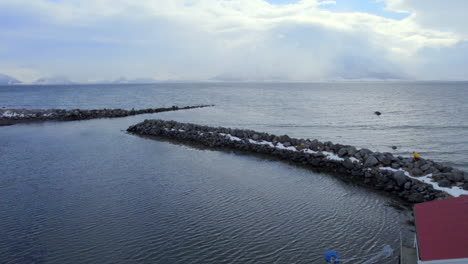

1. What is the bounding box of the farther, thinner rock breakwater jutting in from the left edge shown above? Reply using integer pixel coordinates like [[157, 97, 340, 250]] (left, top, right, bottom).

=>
[[0, 105, 213, 126]]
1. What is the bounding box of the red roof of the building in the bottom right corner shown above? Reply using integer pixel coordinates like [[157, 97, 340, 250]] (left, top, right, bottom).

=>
[[414, 195, 468, 261]]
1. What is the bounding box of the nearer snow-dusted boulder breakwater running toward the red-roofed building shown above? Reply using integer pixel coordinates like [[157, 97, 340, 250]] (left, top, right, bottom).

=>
[[127, 120, 468, 203]]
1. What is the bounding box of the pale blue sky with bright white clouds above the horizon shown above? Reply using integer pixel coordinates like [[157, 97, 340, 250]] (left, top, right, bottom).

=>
[[0, 0, 468, 82]]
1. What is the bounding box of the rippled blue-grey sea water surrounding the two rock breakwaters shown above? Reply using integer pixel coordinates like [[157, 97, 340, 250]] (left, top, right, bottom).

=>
[[0, 83, 468, 264]]
